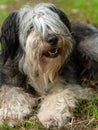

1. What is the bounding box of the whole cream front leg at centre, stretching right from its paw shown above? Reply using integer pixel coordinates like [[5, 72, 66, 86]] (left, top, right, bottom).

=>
[[38, 85, 92, 129]]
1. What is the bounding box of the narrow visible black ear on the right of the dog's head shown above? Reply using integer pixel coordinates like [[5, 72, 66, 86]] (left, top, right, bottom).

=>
[[49, 6, 71, 31]]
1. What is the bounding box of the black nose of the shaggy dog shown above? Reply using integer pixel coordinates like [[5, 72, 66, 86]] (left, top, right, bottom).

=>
[[47, 34, 58, 45]]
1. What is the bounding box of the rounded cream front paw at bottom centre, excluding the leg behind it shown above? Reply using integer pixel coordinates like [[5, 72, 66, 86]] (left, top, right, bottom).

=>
[[37, 95, 72, 130]]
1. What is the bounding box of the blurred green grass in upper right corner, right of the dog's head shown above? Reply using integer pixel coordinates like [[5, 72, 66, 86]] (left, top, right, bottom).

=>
[[57, 0, 98, 24]]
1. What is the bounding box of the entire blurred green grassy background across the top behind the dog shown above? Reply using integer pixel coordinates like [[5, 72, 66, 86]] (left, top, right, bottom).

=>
[[0, 0, 98, 26]]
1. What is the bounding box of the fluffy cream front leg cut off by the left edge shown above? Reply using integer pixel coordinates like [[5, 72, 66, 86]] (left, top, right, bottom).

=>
[[0, 85, 36, 124]]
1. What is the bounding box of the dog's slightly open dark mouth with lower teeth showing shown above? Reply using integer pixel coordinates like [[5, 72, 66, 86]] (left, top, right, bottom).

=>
[[43, 48, 61, 58]]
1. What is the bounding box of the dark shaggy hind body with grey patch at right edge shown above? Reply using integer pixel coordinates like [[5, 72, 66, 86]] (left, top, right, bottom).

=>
[[71, 23, 98, 90]]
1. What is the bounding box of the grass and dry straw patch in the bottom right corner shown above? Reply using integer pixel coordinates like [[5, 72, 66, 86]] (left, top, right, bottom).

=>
[[65, 95, 98, 130]]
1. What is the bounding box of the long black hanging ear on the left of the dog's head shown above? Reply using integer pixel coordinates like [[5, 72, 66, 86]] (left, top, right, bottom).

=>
[[0, 12, 19, 63]]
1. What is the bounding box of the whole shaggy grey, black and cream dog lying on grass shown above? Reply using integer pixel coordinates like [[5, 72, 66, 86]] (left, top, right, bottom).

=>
[[0, 3, 98, 129]]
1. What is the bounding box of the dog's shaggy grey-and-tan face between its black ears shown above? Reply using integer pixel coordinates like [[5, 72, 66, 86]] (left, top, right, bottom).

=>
[[19, 4, 72, 81]]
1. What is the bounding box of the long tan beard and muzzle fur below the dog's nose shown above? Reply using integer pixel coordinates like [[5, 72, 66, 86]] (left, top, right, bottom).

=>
[[19, 32, 72, 93]]
